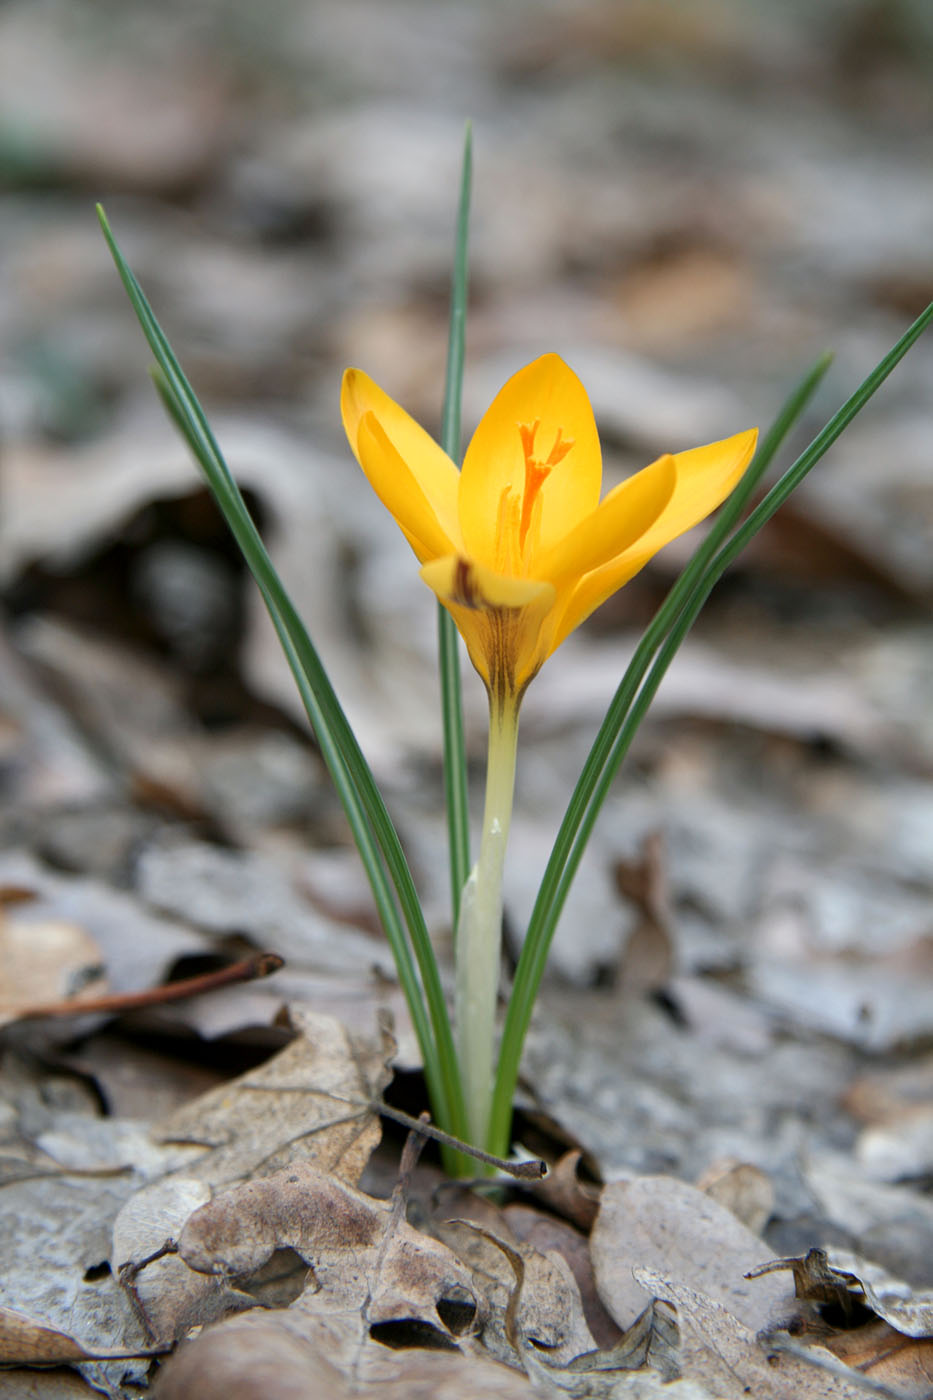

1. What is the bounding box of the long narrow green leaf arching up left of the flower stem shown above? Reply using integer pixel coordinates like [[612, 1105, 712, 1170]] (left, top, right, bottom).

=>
[[98, 206, 465, 1137]]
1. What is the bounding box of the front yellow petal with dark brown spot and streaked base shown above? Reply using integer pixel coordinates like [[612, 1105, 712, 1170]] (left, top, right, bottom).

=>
[[422, 554, 555, 697]]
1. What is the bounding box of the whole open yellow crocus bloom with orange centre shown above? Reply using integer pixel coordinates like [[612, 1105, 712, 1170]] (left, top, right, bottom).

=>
[[342, 354, 758, 706]]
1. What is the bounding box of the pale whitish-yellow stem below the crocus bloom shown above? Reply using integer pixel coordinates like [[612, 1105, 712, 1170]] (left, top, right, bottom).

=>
[[455, 696, 518, 1147]]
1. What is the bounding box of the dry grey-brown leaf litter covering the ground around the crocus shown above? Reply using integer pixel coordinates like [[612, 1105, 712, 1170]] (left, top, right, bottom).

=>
[[0, 0, 933, 1400]]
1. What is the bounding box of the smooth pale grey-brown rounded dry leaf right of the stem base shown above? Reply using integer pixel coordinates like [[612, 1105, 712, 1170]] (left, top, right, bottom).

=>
[[590, 1176, 793, 1333]]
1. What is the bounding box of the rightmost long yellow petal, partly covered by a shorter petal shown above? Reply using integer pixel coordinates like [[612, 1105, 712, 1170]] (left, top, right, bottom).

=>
[[548, 428, 758, 654]]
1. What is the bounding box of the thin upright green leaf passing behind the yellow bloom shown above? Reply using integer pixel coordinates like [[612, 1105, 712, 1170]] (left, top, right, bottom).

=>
[[437, 122, 472, 930]]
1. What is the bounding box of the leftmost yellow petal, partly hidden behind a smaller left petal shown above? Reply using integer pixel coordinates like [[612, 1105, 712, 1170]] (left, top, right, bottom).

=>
[[340, 370, 459, 549]]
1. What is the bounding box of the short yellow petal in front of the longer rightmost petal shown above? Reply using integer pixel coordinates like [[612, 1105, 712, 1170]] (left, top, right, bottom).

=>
[[534, 452, 677, 588]]
